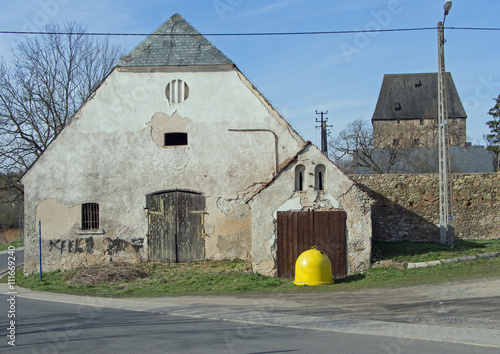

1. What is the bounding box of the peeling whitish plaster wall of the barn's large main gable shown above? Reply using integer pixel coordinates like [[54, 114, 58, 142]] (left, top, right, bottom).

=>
[[22, 67, 304, 273]]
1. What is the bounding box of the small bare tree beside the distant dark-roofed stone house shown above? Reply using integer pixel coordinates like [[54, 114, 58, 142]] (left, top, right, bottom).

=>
[[329, 118, 405, 174]]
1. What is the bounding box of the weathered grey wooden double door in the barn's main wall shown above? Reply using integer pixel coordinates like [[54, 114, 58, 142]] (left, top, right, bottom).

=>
[[146, 191, 205, 263]]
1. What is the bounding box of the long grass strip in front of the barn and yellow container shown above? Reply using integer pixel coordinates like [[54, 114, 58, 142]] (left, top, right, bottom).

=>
[[10, 258, 500, 297]]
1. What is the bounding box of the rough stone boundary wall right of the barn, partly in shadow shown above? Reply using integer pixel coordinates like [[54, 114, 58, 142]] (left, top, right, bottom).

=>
[[350, 173, 500, 242]]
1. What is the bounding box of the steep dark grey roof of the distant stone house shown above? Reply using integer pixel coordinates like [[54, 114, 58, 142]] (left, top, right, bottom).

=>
[[372, 73, 467, 121]]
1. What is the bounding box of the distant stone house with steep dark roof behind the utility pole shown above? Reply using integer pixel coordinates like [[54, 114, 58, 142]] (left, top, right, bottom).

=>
[[372, 73, 467, 148]]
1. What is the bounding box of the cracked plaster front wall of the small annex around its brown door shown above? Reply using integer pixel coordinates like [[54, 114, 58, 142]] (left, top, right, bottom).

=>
[[250, 145, 372, 275]]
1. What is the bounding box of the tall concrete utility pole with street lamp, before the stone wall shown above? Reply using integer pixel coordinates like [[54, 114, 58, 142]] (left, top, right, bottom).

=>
[[438, 1, 455, 247]]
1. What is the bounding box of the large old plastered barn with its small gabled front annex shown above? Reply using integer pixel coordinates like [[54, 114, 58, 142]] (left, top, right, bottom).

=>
[[22, 14, 371, 274]]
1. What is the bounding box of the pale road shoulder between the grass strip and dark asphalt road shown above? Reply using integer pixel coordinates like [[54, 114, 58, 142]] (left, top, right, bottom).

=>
[[0, 278, 500, 348]]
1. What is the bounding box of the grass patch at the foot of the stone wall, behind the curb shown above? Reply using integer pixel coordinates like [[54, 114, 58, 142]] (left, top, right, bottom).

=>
[[372, 240, 500, 263]]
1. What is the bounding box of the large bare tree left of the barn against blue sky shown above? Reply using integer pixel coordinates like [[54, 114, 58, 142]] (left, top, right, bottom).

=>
[[0, 22, 123, 198]]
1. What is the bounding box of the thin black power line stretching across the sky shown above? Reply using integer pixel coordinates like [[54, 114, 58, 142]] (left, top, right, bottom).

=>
[[0, 27, 500, 37]]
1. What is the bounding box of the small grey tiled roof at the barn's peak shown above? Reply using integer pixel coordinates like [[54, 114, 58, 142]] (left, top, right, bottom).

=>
[[117, 14, 233, 67]]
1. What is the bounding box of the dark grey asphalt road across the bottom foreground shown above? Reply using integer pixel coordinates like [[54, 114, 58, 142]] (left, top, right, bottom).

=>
[[0, 295, 498, 354]]
